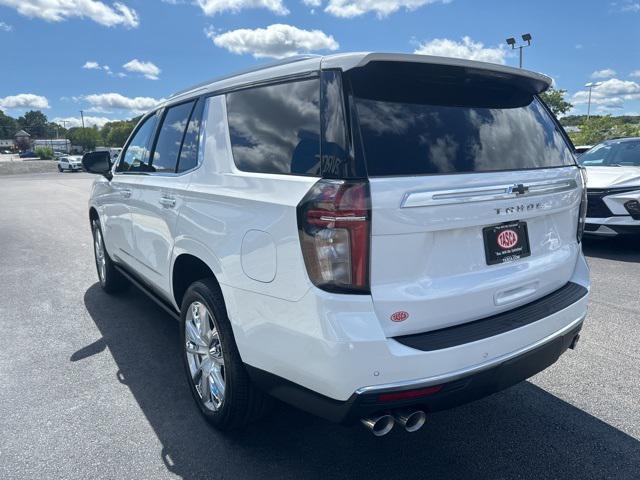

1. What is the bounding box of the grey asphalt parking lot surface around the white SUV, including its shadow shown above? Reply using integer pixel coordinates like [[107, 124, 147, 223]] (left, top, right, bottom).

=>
[[0, 173, 640, 480]]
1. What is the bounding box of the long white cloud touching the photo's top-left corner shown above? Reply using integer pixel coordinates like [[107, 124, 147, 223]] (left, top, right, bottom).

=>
[[0, 0, 140, 28]]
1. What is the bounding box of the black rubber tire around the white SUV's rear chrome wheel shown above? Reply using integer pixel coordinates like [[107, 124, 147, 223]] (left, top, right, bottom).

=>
[[180, 279, 274, 431]]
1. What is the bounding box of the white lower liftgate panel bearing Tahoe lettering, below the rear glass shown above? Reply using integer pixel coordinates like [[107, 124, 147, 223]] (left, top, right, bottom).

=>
[[370, 167, 580, 336]]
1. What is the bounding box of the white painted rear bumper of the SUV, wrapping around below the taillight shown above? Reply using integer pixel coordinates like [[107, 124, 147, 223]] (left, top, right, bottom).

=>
[[232, 255, 589, 404]]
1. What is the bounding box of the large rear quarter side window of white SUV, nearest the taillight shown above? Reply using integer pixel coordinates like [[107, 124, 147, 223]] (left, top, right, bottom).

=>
[[226, 79, 320, 175]]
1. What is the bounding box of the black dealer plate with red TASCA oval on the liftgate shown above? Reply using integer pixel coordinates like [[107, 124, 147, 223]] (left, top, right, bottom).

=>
[[482, 221, 531, 265]]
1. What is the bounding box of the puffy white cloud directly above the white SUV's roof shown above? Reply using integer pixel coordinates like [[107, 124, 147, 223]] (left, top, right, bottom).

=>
[[205, 23, 340, 58]]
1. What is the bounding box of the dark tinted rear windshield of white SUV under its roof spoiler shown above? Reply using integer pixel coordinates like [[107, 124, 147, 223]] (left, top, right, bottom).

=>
[[351, 62, 575, 176]]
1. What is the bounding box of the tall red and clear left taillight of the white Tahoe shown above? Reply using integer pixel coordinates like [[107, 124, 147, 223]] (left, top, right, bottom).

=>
[[298, 180, 371, 293]]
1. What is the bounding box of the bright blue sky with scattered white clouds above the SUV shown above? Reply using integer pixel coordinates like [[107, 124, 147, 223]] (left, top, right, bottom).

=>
[[0, 0, 640, 126]]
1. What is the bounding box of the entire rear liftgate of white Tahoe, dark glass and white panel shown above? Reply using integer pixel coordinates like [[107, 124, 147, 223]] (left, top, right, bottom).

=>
[[351, 61, 581, 336]]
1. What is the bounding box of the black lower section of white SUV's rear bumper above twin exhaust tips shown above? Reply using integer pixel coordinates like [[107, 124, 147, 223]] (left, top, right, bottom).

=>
[[247, 317, 584, 424]]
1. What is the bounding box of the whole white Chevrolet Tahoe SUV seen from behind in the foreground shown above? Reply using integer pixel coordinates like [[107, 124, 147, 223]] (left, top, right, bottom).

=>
[[83, 53, 589, 435]]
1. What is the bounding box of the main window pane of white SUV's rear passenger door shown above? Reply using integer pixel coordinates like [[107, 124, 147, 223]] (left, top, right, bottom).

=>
[[150, 102, 195, 173]]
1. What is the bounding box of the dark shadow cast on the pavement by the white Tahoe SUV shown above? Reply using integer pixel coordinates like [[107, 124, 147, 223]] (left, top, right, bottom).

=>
[[81, 283, 640, 480]]
